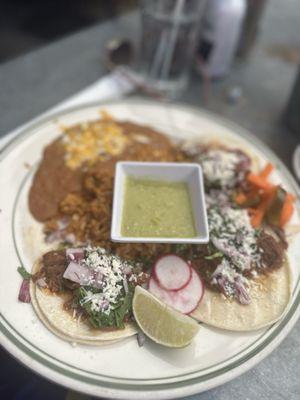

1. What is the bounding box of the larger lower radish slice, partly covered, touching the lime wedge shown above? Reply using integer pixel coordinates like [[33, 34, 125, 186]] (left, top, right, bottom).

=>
[[149, 268, 204, 314]]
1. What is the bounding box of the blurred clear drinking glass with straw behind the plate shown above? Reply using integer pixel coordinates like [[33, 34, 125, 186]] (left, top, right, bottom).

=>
[[139, 0, 206, 97]]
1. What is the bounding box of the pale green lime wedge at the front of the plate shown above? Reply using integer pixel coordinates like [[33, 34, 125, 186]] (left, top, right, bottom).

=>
[[132, 286, 199, 347]]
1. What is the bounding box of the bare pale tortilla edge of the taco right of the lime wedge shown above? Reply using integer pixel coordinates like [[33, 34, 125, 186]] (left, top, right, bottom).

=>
[[191, 260, 291, 331]]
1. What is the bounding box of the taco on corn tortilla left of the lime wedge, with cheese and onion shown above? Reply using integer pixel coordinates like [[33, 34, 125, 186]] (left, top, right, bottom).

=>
[[30, 247, 147, 345]]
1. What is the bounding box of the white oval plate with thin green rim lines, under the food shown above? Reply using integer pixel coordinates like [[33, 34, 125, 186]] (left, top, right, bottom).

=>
[[0, 101, 300, 399]]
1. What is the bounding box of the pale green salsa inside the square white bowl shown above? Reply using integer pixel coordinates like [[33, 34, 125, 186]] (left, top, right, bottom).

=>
[[121, 177, 196, 238]]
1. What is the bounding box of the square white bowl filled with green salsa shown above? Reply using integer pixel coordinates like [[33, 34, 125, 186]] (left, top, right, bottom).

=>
[[111, 162, 209, 243]]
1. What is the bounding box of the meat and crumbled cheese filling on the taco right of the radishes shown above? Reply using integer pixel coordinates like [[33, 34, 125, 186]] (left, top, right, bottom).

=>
[[195, 196, 286, 304]]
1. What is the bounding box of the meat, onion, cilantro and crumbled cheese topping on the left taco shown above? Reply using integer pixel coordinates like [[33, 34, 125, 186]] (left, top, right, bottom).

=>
[[32, 247, 147, 329]]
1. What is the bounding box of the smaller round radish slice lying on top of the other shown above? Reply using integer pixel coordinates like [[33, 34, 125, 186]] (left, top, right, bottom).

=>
[[153, 254, 192, 290]]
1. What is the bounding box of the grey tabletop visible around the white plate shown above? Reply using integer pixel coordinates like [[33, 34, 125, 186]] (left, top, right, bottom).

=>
[[0, 0, 300, 400]]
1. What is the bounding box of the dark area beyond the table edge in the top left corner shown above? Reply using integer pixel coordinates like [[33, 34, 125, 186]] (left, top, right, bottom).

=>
[[0, 0, 137, 61]]
